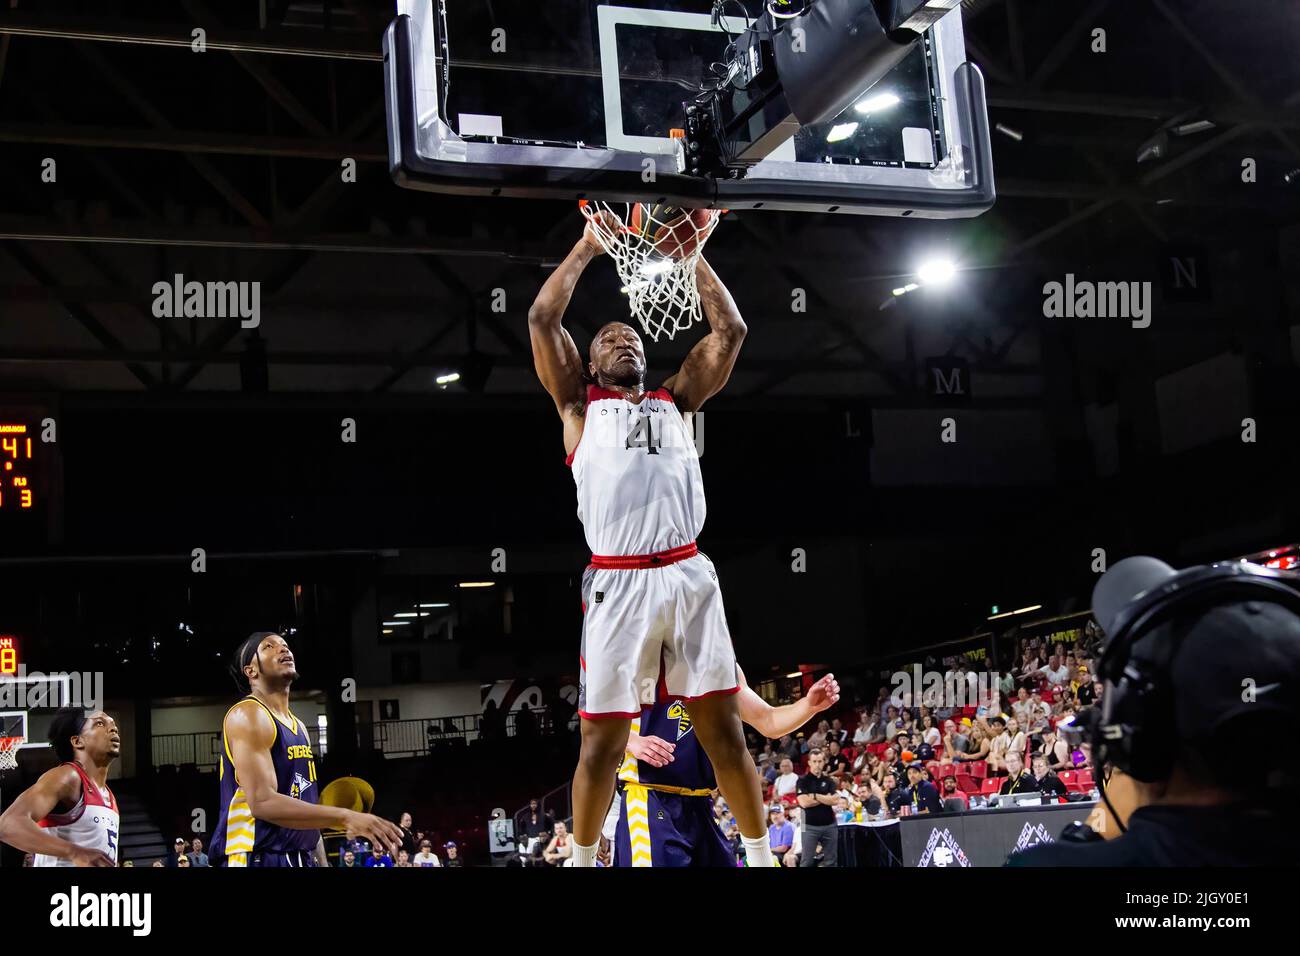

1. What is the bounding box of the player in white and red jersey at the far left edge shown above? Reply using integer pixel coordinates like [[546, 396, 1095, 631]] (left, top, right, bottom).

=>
[[0, 708, 122, 866]]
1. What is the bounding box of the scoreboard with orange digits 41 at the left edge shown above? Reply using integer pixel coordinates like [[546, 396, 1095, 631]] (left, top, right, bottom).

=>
[[0, 395, 62, 554]]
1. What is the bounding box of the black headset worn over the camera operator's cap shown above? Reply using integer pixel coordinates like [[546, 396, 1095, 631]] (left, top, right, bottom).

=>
[[1091, 562, 1300, 783]]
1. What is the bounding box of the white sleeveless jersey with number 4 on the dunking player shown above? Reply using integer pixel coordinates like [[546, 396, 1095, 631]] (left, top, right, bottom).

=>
[[568, 385, 705, 555]]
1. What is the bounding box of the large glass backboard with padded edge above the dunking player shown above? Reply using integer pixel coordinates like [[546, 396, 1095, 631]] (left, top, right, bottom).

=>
[[385, 0, 995, 219]]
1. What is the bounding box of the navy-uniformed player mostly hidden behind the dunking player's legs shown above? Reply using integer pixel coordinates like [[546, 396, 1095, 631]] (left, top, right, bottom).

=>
[[611, 671, 840, 866]]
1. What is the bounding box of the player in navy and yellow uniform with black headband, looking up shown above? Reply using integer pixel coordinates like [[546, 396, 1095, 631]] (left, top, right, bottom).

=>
[[209, 631, 402, 868]]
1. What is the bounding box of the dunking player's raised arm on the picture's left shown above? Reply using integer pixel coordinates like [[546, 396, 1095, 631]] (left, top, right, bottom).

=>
[[528, 224, 603, 442]]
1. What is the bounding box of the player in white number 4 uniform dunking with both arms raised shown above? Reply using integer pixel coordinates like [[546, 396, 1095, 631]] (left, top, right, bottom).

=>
[[528, 214, 772, 866]]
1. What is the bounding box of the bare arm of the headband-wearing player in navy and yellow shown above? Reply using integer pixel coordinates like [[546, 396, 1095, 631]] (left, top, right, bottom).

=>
[[225, 700, 402, 853]]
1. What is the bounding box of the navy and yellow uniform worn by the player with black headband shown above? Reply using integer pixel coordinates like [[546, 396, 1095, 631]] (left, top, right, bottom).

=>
[[209, 696, 321, 866]]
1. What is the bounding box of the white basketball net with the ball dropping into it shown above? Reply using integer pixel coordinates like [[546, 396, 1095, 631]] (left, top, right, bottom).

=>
[[581, 200, 719, 342]]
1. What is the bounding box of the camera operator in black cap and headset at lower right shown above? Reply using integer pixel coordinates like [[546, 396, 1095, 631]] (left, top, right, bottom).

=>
[[1008, 557, 1300, 866]]
